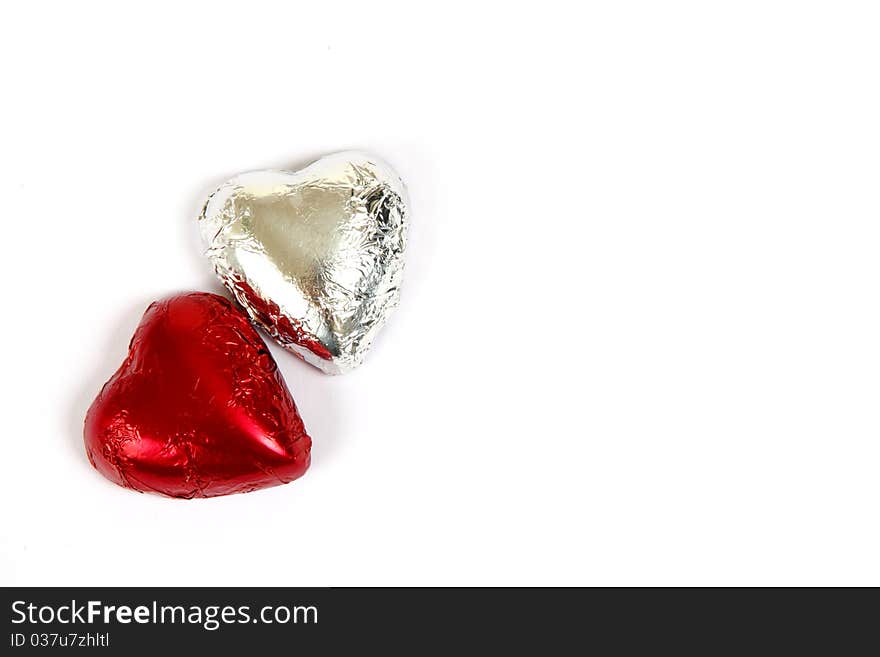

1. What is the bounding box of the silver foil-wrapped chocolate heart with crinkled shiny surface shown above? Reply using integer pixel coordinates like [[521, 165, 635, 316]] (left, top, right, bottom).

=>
[[199, 152, 408, 374]]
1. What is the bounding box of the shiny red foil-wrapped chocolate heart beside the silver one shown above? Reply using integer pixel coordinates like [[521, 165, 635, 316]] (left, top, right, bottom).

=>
[[85, 292, 311, 498]]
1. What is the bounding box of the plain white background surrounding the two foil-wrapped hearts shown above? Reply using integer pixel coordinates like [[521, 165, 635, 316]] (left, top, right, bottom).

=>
[[0, 2, 880, 585]]
